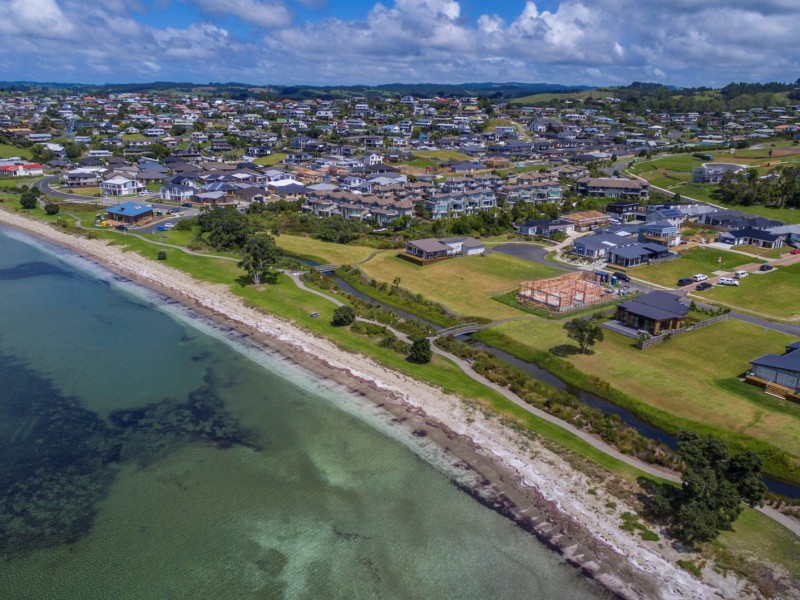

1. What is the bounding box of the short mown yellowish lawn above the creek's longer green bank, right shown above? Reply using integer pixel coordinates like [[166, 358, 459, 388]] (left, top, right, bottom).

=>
[[493, 319, 800, 464]]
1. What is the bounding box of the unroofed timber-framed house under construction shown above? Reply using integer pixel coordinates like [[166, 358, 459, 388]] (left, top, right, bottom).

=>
[[517, 271, 608, 312]]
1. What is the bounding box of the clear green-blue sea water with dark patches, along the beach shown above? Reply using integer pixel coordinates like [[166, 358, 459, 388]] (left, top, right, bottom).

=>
[[0, 229, 606, 600]]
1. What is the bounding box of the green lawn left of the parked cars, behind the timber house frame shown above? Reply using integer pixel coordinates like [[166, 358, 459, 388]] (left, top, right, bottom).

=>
[[629, 248, 763, 287]]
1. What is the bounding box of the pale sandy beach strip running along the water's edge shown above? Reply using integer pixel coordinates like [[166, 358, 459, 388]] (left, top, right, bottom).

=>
[[0, 210, 747, 598]]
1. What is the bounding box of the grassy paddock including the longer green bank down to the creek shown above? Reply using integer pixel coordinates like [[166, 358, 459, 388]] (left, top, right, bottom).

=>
[[475, 320, 800, 481]]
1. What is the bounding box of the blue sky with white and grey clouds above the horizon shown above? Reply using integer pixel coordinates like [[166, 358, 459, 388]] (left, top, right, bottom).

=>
[[0, 0, 800, 87]]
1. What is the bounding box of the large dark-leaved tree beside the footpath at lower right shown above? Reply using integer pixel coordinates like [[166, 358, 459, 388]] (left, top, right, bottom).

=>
[[675, 432, 767, 542]]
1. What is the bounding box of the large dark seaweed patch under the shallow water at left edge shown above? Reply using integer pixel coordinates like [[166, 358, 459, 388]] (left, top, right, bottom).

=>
[[0, 354, 258, 557]]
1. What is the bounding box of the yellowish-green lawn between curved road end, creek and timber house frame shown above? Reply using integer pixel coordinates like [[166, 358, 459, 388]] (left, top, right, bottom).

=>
[[360, 252, 563, 319]]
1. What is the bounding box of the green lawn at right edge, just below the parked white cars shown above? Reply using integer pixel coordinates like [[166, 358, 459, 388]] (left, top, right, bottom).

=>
[[703, 257, 800, 318]]
